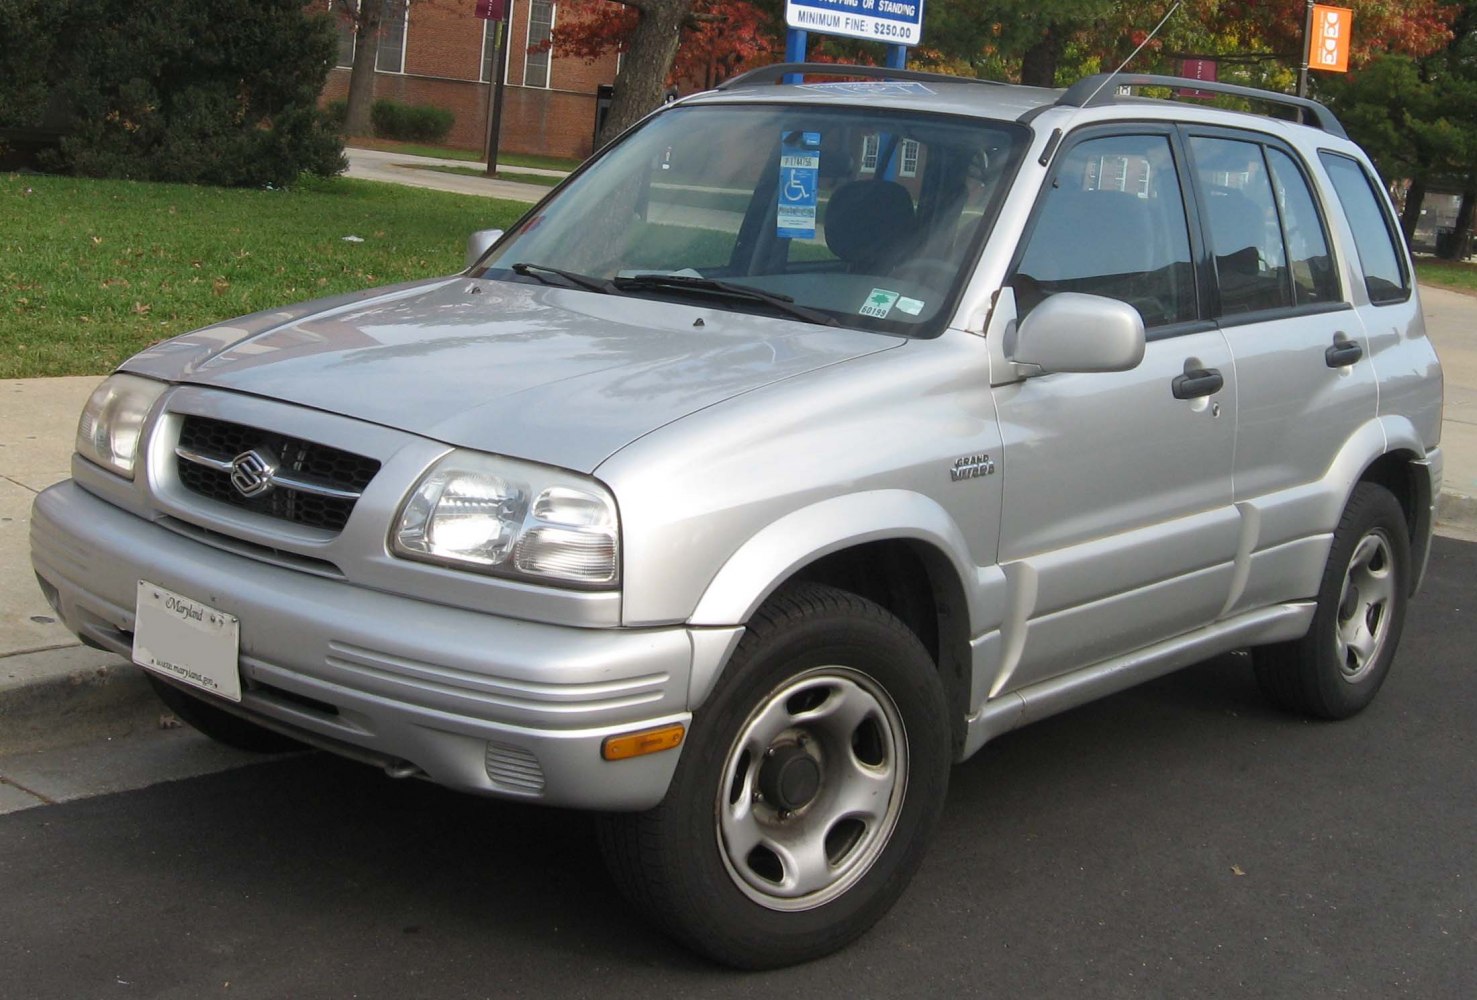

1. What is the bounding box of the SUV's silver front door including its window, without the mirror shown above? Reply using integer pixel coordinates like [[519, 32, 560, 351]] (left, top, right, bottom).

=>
[[991, 126, 1239, 696]]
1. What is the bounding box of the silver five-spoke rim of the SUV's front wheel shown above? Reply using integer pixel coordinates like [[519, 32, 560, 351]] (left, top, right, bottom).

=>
[[715, 666, 908, 911]]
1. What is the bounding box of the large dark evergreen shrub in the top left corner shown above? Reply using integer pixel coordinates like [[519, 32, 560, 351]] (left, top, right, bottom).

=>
[[0, 0, 344, 186]]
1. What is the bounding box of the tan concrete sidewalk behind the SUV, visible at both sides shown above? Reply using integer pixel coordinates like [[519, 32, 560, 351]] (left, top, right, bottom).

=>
[[0, 290, 1477, 752]]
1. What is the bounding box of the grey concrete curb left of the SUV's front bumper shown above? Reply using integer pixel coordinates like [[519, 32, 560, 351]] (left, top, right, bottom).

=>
[[0, 645, 160, 755]]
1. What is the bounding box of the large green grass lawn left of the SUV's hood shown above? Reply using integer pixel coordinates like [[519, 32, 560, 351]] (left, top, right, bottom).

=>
[[0, 174, 527, 378]]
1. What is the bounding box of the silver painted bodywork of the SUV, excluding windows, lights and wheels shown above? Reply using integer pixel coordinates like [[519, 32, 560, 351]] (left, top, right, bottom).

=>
[[32, 84, 1442, 808]]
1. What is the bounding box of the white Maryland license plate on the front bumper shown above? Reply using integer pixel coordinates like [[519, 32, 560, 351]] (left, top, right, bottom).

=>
[[133, 581, 241, 702]]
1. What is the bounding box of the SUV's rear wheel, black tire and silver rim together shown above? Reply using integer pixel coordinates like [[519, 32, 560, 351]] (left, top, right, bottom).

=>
[[1252, 483, 1411, 719]]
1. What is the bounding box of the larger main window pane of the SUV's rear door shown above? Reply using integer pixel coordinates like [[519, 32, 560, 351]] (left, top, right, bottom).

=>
[[1190, 136, 1294, 316]]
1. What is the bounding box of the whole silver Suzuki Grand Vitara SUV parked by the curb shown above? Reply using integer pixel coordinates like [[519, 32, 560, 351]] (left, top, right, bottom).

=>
[[32, 66, 1442, 968]]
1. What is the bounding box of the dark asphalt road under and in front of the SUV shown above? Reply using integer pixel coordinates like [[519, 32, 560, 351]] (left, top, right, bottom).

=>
[[0, 538, 1477, 1000]]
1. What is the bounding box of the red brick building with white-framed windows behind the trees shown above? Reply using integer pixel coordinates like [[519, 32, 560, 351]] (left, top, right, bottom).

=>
[[323, 0, 616, 157]]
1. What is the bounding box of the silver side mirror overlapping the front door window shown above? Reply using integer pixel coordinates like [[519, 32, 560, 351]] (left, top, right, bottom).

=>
[[1006, 291, 1145, 375]]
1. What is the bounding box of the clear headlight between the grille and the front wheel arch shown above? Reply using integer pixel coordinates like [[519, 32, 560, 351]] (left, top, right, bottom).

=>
[[390, 452, 620, 586]]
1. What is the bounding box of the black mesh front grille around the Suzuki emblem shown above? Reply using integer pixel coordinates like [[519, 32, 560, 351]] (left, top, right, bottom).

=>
[[176, 417, 380, 532]]
